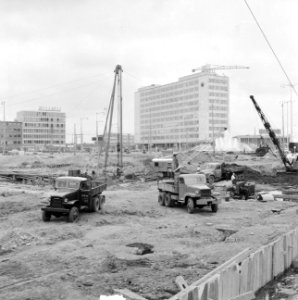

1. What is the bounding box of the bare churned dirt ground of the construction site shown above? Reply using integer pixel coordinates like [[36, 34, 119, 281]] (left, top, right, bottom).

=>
[[0, 154, 298, 300]]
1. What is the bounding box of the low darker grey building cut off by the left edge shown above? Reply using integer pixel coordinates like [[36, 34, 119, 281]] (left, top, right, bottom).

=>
[[0, 121, 22, 153]]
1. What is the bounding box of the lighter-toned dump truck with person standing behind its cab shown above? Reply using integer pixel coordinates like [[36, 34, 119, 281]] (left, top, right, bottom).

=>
[[158, 174, 220, 214]]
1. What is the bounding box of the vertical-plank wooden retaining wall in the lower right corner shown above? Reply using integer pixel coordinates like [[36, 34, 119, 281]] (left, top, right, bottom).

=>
[[169, 228, 298, 300]]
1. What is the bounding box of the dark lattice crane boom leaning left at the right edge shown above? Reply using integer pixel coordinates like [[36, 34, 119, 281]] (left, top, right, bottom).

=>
[[250, 95, 298, 172]]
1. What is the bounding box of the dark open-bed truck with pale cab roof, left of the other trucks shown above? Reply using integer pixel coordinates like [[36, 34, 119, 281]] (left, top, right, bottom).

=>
[[41, 176, 107, 222]]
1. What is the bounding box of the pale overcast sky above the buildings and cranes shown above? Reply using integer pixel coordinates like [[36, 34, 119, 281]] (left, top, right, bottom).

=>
[[0, 0, 298, 141]]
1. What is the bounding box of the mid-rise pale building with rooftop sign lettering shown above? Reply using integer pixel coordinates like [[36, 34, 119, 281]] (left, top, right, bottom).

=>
[[17, 107, 65, 150]]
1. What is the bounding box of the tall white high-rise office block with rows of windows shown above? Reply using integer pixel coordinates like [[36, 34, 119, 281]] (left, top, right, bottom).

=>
[[135, 71, 229, 147]]
